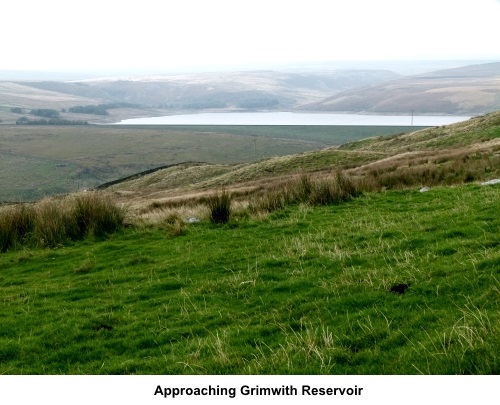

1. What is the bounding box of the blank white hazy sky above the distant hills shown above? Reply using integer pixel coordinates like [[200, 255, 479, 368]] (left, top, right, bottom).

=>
[[0, 0, 500, 71]]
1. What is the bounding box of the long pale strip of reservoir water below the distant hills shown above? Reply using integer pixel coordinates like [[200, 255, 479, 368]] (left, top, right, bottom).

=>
[[117, 112, 470, 127]]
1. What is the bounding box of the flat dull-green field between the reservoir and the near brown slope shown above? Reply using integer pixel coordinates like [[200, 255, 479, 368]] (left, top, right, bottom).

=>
[[0, 125, 424, 201]]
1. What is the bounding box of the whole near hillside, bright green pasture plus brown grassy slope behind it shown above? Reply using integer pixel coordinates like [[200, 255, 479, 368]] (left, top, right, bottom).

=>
[[0, 109, 500, 374]]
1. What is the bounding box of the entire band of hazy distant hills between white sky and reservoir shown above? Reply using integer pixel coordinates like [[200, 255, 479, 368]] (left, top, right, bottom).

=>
[[0, 62, 500, 124]]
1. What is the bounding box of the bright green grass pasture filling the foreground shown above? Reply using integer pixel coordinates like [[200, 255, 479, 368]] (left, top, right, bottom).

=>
[[0, 185, 500, 374]]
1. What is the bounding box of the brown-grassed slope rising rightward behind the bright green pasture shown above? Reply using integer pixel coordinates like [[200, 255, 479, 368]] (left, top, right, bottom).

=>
[[109, 112, 500, 212]]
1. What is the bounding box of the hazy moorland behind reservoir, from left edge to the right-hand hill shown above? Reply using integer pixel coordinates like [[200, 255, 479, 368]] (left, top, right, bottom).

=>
[[0, 69, 400, 124]]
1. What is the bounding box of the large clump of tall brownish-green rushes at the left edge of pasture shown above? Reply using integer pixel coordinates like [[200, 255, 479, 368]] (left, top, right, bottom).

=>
[[0, 192, 125, 252]]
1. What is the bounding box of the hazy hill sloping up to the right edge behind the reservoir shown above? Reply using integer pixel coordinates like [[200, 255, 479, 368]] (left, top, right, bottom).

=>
[[302, 63, 500, 115]]
